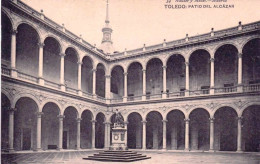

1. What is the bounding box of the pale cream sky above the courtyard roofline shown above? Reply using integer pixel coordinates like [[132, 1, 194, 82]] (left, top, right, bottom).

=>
[[22, 0, 260, 52]]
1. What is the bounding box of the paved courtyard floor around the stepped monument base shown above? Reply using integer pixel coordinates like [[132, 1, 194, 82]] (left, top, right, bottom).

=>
[[1, 151, 260, 164]]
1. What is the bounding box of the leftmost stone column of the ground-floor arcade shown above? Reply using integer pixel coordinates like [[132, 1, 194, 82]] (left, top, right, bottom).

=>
[[8, 108, 16, 152]]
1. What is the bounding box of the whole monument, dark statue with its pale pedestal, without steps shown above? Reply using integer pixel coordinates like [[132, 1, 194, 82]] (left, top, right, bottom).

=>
[[109, 109, 127, 151]]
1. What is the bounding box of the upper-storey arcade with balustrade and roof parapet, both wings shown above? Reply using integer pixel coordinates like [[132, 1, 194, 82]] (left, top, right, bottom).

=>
[[1, 1, 260, 103]]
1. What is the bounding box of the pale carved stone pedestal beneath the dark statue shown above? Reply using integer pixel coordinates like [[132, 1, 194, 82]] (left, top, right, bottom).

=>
[[109, 126, 127, 151]]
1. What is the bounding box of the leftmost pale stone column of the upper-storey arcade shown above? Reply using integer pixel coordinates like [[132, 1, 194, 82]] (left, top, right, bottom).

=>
[[11, 30, 17, 77]]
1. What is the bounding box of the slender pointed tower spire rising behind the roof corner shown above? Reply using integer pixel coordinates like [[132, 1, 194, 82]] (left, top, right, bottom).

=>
[[99, 0, 114, 54]]
